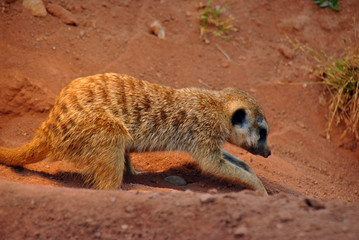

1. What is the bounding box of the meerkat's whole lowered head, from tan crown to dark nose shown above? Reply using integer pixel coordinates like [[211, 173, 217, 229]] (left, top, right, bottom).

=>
[[221, 88, 271, 158]]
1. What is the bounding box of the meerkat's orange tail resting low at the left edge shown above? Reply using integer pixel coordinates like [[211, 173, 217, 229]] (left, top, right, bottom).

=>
[[0, 135, 48, 166]]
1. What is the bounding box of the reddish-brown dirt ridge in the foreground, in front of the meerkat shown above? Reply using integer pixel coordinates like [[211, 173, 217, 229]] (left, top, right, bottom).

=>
[[0, 181, 359, 239]]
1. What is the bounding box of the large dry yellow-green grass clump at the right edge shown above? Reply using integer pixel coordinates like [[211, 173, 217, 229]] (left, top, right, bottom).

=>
[[290, 20, 359, 140]]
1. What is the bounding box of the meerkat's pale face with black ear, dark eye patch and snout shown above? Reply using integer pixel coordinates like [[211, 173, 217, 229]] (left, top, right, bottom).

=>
[[229, 108, 271, 158]]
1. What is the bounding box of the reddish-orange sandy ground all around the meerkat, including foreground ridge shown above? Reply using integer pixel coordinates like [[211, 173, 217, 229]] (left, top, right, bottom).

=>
[[0, 0, 359, 239]]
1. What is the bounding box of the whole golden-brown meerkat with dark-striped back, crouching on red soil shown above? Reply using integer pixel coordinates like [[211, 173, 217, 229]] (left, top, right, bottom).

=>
[[0, 73, 271, 194]]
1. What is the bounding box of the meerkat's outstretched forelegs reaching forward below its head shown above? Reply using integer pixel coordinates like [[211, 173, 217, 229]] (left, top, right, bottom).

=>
[[195, 151, 268, 195]]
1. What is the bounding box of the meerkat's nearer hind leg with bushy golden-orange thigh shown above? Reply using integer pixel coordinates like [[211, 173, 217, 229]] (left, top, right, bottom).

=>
[[70, 116, 128, 190]]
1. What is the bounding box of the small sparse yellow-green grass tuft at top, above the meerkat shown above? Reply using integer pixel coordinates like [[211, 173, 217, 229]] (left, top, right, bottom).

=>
[[199, 0, 237, 42]]
